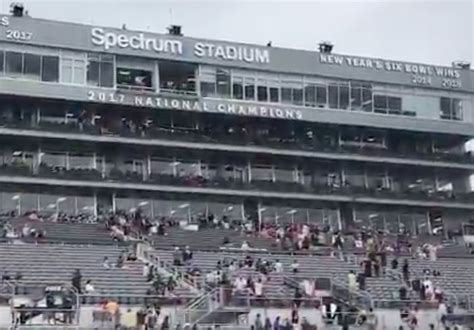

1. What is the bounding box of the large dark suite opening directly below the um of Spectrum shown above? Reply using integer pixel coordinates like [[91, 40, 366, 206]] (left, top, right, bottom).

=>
[[159, 61, 196, 95]]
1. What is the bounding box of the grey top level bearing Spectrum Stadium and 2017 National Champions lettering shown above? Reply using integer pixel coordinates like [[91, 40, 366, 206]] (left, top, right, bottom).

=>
[[0, 15, 474, 135]]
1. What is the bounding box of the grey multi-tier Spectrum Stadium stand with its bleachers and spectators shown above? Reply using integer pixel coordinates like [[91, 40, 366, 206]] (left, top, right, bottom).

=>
[[0, 1, 474, 330]]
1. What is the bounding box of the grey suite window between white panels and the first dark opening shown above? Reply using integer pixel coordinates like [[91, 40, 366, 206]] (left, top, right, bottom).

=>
[[87, 54, 114, 87]]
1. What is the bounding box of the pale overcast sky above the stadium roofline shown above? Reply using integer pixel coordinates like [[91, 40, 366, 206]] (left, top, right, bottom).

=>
[[0, 0, 474, 65]]
